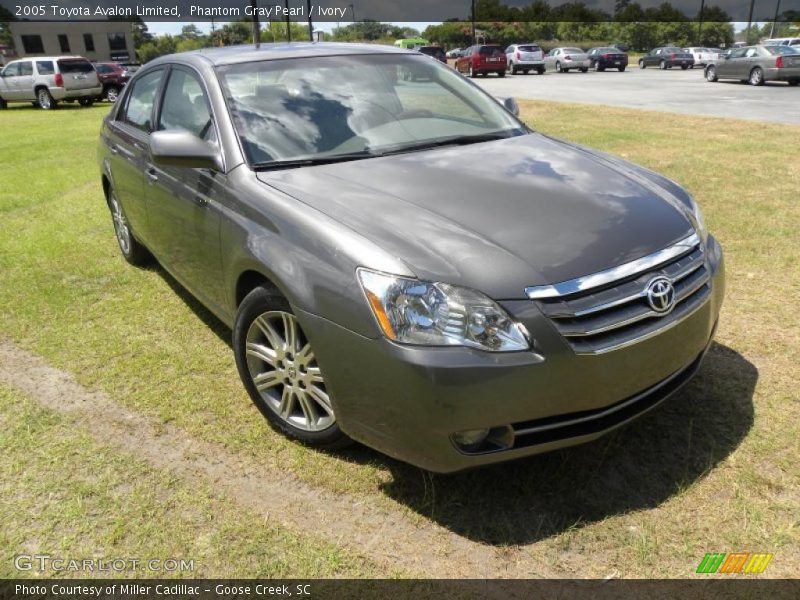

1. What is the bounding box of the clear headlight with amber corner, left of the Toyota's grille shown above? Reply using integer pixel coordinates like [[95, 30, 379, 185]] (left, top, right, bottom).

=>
[[358, 269, 530, 352]]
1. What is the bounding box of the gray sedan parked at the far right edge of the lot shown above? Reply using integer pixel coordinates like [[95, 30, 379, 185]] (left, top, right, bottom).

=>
[[705, 46, 800, 86]]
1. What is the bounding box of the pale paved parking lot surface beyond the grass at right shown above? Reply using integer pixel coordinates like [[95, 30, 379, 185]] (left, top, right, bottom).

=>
[[475, 65, 800, 125]]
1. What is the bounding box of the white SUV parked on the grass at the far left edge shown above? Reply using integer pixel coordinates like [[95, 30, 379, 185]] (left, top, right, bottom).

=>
[[0, 56, 103, 110]]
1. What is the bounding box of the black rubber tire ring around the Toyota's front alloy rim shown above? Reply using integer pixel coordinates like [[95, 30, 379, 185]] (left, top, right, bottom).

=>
[[233, 287, 349, 448]]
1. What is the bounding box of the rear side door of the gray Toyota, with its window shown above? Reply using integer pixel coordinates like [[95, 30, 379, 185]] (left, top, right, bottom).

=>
[[105, 67, 166, 244]]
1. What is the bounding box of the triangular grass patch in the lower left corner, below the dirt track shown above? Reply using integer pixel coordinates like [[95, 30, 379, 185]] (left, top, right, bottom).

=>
[[0, 386, 378, 578]]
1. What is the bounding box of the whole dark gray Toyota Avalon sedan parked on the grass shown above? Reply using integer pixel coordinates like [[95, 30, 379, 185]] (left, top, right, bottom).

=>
[[99, 44, 724, 472]]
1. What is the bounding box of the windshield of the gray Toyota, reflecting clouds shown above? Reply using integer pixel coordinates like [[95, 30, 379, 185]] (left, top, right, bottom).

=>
[[218, 54, 528, 166]]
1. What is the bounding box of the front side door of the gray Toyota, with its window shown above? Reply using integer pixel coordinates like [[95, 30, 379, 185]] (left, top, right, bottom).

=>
[[146, 65, 226, 308]]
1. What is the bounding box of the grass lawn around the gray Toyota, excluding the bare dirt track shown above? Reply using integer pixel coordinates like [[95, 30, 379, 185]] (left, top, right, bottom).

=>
[[0, 101, 800, 577]]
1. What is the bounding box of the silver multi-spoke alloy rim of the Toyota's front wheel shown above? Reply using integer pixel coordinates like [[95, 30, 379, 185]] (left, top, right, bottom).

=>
[[245, 311, 336, 431]]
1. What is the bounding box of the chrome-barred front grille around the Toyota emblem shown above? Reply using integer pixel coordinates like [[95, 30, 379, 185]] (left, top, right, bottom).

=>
[[526, 235, 711, 354]]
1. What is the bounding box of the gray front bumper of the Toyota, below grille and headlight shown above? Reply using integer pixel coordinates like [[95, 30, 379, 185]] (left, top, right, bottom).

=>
[[298, 237, 725, 472]]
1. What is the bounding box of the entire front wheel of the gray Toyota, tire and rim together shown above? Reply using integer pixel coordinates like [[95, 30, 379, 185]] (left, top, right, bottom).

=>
[[228, 287, 350, 449]]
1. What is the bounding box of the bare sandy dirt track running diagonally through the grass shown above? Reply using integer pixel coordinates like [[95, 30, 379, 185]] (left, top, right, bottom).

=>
[[0, 340, 547, 578]]
